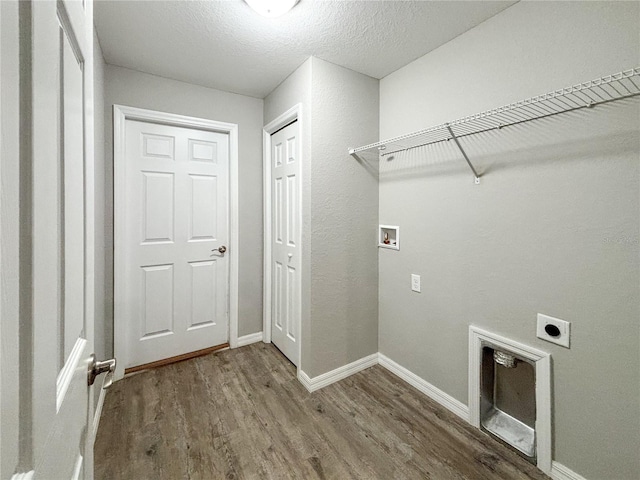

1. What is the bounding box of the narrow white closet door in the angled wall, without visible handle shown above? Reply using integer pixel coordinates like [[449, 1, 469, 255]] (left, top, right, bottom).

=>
[[270, 122, 301, 366]]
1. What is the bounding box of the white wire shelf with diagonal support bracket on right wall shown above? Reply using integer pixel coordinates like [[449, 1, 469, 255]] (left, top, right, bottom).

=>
[[349, 67, 640, 183]]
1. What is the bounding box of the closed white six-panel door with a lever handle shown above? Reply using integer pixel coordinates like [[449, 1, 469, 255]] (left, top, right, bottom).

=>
[[121, 120, 229, 368]]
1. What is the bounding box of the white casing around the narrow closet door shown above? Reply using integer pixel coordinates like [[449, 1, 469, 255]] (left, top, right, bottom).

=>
[[262, 103, 305, 372]]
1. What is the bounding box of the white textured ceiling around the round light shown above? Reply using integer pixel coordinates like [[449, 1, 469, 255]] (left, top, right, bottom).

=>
[[95, 0, 515, 98]]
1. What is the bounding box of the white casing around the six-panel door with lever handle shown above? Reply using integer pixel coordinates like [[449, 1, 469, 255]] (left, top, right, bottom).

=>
[[113, 105, 239, 380]]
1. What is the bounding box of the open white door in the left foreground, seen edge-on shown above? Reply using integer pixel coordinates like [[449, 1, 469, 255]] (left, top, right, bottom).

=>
[[28, 0, 106, 479]]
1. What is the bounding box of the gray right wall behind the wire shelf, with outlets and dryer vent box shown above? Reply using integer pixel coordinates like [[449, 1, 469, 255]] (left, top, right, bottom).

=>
[[379, 2, 640, 479]]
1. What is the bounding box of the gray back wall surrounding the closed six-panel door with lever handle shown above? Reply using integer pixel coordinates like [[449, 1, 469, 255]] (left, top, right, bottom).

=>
[[105, 65, 263, 352]]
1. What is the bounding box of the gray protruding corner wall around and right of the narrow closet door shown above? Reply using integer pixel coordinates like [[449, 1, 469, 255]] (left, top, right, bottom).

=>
[[264, 57, 379, 377]]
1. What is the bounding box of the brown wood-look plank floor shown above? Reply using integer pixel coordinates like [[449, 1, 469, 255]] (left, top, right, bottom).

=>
[[95, 343, 548, 480]]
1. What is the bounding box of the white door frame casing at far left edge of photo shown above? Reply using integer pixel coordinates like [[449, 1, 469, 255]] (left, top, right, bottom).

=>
[[0, 0, 20, 478]]
